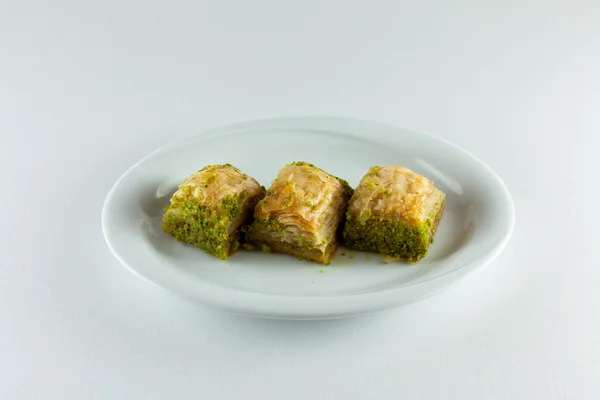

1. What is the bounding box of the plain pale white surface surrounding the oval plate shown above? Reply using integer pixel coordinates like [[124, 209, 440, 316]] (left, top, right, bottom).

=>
[[0, 0, 600, 400]]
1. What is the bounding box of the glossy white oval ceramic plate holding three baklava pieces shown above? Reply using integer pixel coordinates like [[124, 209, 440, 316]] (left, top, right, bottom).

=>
[[102, 117, 514, 319]]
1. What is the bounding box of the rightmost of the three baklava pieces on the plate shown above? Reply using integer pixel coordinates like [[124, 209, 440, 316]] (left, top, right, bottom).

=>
[[344, 166, 445, 262]]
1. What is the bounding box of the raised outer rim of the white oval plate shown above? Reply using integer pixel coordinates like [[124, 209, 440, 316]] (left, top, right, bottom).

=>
[[101, 115, 515, 319]]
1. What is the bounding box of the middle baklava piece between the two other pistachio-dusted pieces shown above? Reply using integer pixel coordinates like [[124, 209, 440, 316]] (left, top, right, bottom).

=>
[[249, 162, 352, 263]]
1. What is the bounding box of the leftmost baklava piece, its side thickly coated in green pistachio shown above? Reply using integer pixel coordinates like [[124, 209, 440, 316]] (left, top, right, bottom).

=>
[[163, 164, 264, 259]]
